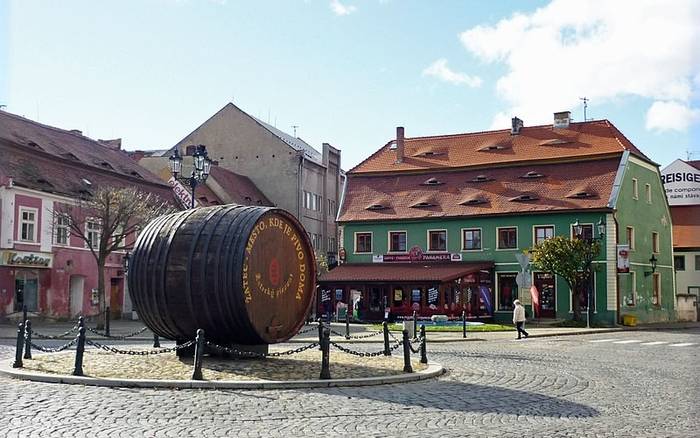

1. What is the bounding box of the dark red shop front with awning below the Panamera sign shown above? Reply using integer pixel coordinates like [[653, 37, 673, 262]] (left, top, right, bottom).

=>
[[317, 263, 494, 321]]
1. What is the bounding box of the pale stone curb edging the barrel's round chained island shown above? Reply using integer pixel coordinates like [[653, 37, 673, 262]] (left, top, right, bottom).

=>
[[0, 361, 445, 389]]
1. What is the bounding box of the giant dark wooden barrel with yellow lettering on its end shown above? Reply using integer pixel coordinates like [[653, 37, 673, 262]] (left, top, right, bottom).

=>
[[128, 205, 316, 345]]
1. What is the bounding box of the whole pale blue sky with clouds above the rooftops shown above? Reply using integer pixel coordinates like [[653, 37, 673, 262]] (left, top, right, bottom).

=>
[[0, 0, 700, 169]]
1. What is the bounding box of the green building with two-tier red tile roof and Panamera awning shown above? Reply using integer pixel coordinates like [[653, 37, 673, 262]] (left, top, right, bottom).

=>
[[319, 112, 676, 325]]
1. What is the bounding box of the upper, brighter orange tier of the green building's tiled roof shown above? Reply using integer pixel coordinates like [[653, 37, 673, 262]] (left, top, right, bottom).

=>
[[348, 120, 649, 174]]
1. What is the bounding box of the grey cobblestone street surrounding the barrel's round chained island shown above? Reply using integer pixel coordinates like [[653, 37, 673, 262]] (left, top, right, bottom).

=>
[[0, 329, 700, 437]]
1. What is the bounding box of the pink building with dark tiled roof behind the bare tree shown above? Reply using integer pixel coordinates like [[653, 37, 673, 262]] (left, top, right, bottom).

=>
[[0, 111, 173, 318]]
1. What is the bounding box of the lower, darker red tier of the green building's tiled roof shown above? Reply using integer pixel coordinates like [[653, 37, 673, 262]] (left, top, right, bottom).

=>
[[339, 157, 620, 222]]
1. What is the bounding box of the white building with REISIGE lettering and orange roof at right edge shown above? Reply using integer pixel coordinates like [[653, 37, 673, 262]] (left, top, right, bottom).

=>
[[661, 160, 700, 321]]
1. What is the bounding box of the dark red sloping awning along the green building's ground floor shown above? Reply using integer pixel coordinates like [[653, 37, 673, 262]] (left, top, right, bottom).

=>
[[319, 262, 493, 283]]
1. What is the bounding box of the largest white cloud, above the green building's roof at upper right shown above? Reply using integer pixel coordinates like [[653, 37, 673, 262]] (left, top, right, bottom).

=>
[[460, 0, 700, 129]]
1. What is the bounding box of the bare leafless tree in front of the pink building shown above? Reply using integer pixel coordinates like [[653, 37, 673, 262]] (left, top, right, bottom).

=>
[[53, 186, 172, 326]]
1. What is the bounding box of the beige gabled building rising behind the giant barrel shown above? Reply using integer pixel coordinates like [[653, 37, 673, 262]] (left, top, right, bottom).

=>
[[150, 103, 342, 260]]
